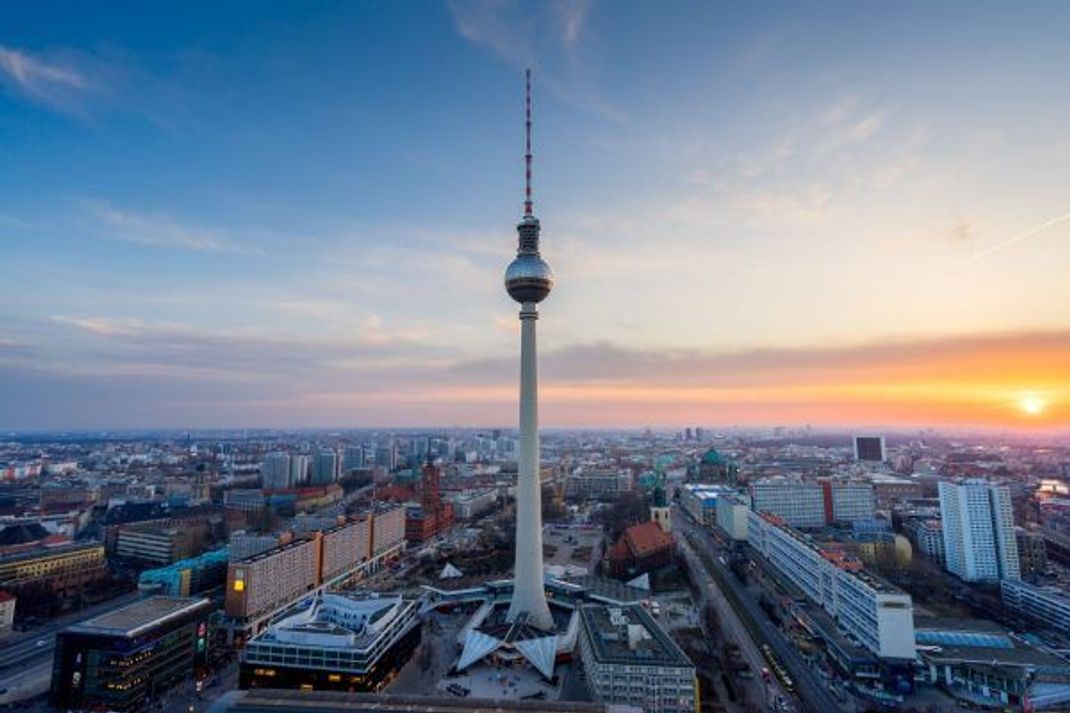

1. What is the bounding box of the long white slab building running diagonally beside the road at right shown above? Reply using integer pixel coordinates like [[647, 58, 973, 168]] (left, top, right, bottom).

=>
[[747, 513, 915, 662]]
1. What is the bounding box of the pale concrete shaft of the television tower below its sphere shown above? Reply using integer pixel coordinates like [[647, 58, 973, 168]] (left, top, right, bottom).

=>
[[506, 302, 553, 629]]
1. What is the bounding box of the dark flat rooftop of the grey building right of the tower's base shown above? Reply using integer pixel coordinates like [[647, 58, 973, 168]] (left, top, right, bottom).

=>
[[580, 604, 693, 667]]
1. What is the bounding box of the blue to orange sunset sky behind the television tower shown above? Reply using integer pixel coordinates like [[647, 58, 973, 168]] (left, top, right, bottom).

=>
[[0, 0, 1070, 429]]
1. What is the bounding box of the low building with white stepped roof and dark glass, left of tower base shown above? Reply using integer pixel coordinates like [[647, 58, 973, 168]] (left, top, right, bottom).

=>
[[240, 593, 421, 692]]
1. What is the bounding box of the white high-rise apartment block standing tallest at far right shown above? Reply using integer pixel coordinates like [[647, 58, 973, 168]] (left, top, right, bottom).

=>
[[938, 479, 1020, 581]]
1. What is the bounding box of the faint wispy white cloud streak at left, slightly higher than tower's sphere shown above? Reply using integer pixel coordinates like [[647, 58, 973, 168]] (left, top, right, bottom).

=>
[[86, 201, 263, 255]]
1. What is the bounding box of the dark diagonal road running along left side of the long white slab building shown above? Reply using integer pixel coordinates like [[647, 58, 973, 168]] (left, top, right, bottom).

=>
[[673, 510, 847, 713]]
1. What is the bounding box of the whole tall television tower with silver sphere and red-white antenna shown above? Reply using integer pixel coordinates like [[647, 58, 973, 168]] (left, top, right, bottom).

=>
[[505, 70, 553, 629]]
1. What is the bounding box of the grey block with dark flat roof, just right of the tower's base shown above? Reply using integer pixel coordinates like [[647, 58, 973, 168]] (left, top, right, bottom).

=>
[[579, 605, 699, 713]]
